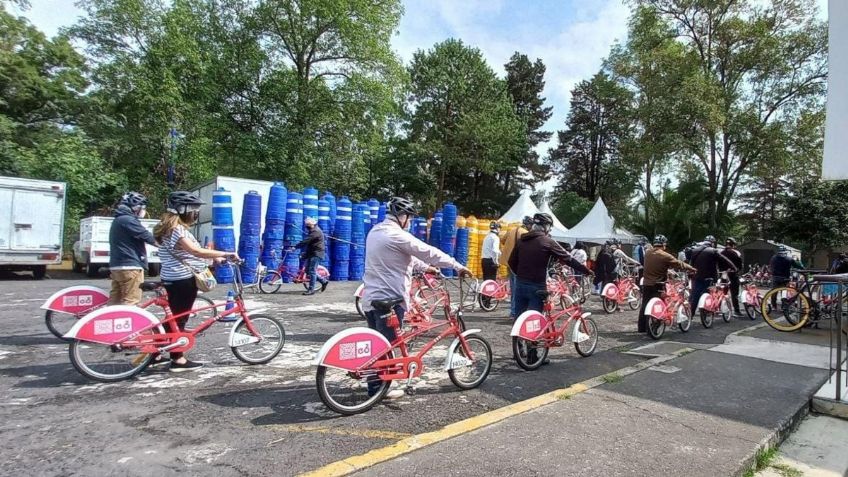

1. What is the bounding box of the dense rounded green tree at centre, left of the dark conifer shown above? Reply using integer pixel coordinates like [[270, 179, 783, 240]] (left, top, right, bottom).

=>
[[408, 39, 526, 213]]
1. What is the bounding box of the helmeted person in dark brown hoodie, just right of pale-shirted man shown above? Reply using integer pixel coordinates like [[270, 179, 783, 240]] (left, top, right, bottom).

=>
[[509, 213, 592, 363]]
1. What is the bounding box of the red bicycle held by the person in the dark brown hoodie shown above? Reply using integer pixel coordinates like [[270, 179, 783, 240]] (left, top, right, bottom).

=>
[[510, 290, 598, 371]]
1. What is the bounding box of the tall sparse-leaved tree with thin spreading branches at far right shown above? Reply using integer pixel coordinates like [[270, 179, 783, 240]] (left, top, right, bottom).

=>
[[638, 0, 827, 229]]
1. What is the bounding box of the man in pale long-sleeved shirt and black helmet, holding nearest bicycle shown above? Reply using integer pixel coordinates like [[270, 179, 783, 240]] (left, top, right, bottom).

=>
[[362, 197, 471, 398]]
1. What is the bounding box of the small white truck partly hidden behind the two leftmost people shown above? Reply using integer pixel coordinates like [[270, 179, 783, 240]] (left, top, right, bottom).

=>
[[73, 217, 160, 277]]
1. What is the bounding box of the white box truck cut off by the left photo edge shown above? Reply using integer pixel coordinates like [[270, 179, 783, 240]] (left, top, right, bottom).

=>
[[0, 177, 67, 280]]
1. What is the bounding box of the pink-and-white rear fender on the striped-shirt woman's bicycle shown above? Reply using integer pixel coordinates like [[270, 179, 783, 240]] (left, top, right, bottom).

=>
[[64, 305, 165, 344]]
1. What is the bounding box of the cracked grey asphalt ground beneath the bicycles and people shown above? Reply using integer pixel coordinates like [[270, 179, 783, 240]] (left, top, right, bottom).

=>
[[0, 272, 823, 475]]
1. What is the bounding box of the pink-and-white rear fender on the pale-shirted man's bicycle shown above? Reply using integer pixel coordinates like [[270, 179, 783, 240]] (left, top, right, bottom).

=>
[[312, 326, 392, 371]]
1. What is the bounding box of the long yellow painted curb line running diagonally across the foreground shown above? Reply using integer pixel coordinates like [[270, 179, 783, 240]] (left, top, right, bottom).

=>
[[300, 348, 694, 477]]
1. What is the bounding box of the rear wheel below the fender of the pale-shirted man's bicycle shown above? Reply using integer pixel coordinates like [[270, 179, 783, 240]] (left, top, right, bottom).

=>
[[315, 352, 392, 416]]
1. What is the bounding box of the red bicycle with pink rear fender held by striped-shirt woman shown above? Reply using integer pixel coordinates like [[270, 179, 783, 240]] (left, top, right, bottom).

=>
[[65, 258, 286, 382]]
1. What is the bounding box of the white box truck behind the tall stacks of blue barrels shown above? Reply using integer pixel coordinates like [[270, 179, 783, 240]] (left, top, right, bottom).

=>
[[192, 176, 274, 245]]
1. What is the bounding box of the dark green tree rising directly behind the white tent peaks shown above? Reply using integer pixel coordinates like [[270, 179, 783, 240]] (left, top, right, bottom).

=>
[[548, 72, 635, 212]]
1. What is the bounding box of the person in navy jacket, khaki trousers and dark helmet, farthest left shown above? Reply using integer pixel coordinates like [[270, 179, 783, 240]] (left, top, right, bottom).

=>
[[109, 192, 156, 305]]
